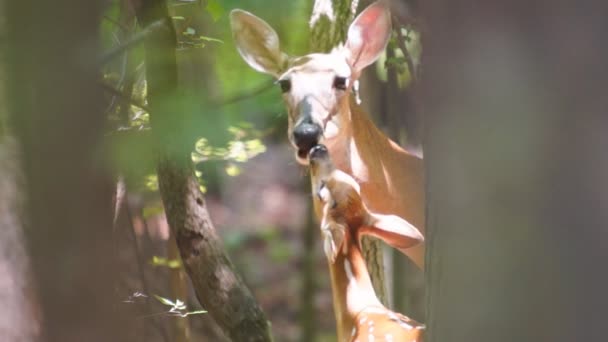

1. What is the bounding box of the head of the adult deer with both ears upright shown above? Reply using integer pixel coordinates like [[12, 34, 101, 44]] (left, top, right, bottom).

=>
[[230, 2, 391, 165]]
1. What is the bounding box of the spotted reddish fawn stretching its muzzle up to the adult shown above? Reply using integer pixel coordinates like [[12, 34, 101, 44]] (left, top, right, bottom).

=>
[[308, 145, 424, 342]]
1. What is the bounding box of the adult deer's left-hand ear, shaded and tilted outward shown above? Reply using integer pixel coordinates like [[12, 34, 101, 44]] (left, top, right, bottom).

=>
[[230, 9, 287, 77]]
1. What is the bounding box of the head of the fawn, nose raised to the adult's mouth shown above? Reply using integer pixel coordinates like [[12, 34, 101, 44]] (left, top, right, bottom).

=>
[[308, 145, 424, 262]]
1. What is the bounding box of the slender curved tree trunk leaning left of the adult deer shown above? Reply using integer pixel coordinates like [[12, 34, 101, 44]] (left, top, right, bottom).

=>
[[137, 0, 271, 341]]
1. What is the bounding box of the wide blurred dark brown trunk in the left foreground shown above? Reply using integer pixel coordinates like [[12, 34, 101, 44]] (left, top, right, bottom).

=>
[[5, 0, 126, 342]]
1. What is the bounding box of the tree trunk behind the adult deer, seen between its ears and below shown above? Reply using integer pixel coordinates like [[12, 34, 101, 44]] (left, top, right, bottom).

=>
[[310, 0, 387, 304]]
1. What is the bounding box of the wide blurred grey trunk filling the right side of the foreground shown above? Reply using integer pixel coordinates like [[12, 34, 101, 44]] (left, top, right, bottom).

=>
[[422, 0, 608, 342]]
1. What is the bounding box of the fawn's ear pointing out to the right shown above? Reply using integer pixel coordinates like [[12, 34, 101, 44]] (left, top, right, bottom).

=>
[[361, 213, 424, 252]]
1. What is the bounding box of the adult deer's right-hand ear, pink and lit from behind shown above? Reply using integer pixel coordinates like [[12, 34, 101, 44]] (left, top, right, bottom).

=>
[[346, 1, 391, 73]]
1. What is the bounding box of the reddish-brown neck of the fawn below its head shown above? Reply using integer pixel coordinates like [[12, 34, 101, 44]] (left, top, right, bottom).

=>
[[329, 230, 384, 341]]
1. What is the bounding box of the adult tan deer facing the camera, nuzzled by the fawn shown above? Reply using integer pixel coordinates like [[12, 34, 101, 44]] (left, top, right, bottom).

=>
[[230, 2, 425, 267]]
